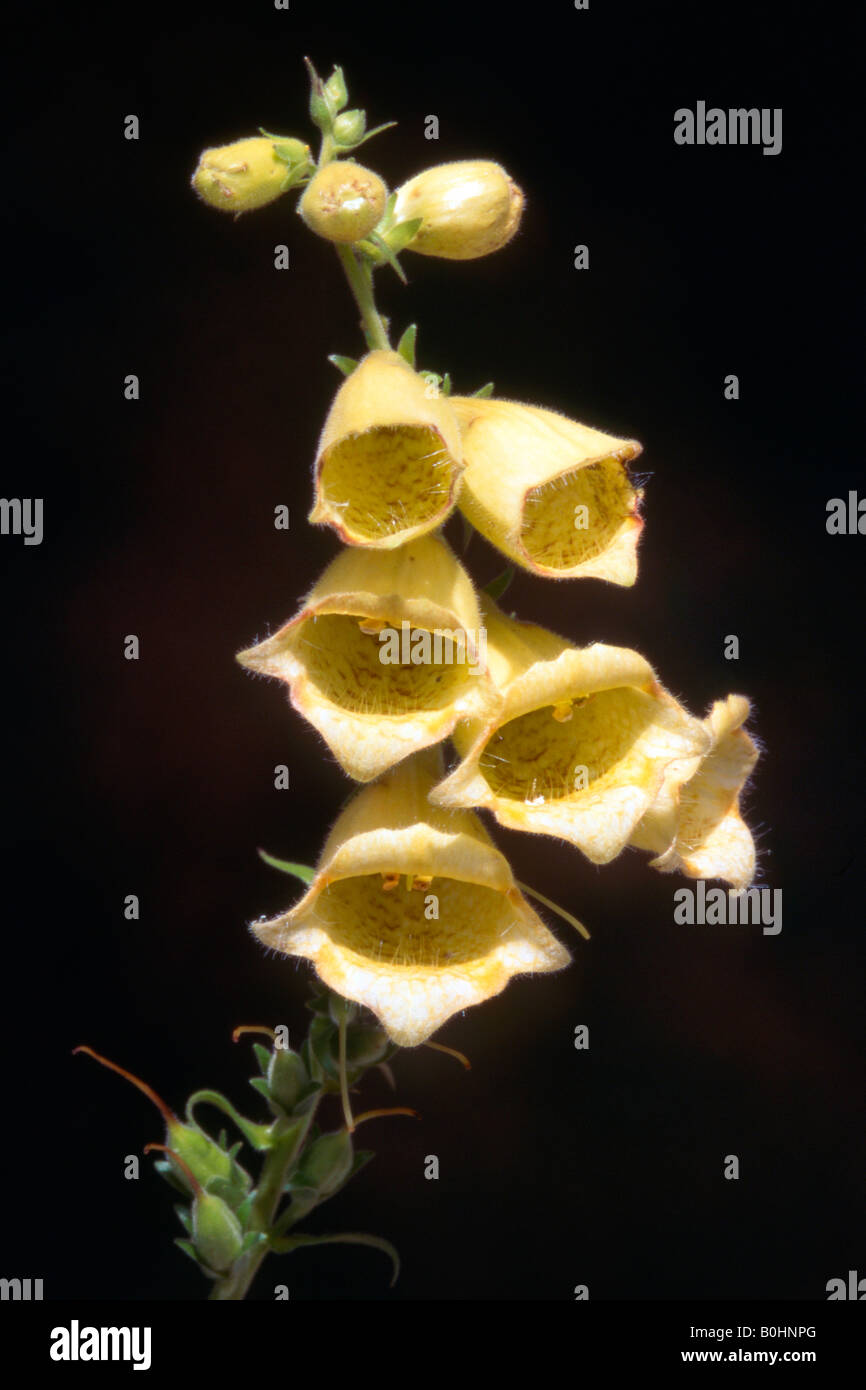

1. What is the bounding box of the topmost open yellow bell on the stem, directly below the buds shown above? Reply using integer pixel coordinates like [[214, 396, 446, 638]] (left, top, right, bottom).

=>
[[310, 349, 463, 549]]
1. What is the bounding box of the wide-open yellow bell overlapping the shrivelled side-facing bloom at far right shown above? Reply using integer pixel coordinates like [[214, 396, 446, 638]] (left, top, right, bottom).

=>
[[432, 599, 709, 863]]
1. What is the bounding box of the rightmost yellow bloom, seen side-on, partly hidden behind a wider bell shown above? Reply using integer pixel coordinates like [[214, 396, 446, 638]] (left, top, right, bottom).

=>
[[631, 695, 759, 890]]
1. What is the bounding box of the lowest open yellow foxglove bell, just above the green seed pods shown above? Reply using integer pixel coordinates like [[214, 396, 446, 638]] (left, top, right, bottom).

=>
[[253, 751, 570, 1047]]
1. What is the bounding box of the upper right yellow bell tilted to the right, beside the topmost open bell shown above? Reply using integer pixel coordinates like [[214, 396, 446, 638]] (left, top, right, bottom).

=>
[[450, 396, 644, 584]]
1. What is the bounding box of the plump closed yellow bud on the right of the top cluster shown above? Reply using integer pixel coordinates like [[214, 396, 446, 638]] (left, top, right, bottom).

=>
[[393, 160, 524, 260]]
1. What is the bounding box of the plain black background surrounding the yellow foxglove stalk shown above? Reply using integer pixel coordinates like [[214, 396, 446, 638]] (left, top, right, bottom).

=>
[[0, 0, 866, 1300]]
